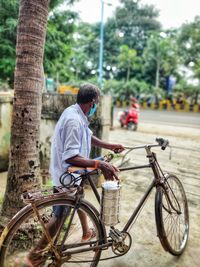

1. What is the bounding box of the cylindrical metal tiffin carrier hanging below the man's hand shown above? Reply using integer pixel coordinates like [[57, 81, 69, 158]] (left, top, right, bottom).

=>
[[101, 181, 121, 226]]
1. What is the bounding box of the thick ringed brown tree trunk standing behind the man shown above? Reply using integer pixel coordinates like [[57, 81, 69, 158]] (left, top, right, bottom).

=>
[[2, 0, 48, 218]]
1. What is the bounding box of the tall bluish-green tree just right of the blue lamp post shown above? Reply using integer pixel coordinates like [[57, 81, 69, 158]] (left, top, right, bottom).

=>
[[101, 0, 161, 79]]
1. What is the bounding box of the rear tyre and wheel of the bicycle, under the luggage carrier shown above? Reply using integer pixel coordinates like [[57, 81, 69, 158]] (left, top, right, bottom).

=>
[[0, 198, 105, 267]]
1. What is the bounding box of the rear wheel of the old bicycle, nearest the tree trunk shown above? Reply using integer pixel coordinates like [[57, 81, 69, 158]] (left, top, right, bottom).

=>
[[0, 198, 103, 267]]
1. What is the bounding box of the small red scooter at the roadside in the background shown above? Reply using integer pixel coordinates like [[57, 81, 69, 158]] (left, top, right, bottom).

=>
[[119, 104, 139, 131]]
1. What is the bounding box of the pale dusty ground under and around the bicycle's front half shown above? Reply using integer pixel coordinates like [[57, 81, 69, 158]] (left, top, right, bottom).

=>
[[0, 118, 200, 267]]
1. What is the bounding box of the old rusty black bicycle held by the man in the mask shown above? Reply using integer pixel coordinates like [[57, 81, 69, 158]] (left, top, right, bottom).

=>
[[0, 138, 189, 267]]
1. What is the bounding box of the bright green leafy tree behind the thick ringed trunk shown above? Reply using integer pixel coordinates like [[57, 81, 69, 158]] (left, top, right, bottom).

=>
[[0, 0, 78, 88]]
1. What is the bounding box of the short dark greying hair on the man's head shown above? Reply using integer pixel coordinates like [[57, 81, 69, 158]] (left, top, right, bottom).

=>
[[76, 83, 100, 104]]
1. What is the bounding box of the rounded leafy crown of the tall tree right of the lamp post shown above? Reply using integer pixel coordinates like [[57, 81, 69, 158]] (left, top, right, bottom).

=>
[[108, 0, 160, 52]]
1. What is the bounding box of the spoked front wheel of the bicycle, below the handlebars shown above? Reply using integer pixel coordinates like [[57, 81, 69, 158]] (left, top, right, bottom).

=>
[[155, 174, 189, 256]]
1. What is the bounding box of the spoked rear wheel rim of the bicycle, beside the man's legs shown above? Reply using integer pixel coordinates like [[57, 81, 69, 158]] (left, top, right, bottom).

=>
[[0, 199, 103, 267]]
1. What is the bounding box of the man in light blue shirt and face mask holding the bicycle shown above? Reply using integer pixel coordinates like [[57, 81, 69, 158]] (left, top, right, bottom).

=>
[[26, 83, 124, 266]]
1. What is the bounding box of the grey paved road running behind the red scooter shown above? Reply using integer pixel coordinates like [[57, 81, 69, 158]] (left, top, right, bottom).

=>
[[114, 108, 200, 128]]
